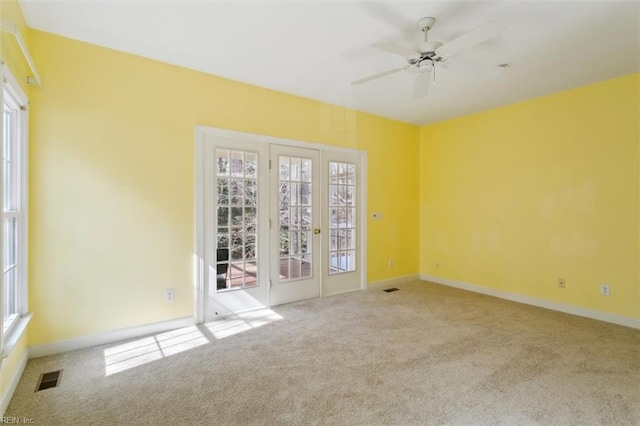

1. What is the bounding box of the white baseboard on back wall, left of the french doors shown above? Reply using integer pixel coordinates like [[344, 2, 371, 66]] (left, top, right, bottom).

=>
[[29, 317, 195, 358]]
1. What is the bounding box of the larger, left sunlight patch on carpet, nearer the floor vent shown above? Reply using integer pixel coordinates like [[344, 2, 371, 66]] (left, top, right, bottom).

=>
[[104, 326, 209, 376]]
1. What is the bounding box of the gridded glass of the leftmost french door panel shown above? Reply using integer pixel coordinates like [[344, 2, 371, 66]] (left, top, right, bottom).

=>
[[215, 149, 259, 291]]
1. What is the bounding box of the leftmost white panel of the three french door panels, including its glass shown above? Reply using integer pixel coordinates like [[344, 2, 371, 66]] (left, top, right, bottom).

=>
[[198, 138, 269, 320]]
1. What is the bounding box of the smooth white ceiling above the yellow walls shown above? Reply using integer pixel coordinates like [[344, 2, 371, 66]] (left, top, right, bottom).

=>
[[20, 0, 640, 124]]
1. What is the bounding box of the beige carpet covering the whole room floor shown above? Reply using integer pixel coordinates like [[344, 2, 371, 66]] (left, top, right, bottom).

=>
[[5, 281, 640, 425]]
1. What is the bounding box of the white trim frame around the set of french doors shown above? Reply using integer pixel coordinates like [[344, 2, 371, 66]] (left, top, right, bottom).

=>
[[194, 126, 367, 323]]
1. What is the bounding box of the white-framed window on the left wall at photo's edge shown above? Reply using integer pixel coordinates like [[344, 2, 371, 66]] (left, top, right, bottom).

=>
[[0, 67, 28, 354]]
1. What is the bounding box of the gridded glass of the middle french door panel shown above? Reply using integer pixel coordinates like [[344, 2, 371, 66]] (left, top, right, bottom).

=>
[[278, 155, 313, 282]]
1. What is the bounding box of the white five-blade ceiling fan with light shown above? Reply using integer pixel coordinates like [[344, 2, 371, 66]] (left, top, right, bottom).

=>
[[351, 17, 508, 99]]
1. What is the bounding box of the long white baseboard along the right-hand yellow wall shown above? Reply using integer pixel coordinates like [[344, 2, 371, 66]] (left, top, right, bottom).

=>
[[420, 274, 640, 329]]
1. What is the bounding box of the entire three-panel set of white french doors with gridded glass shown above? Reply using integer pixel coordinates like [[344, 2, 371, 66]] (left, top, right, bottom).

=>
[[196, 130, 364, 320]]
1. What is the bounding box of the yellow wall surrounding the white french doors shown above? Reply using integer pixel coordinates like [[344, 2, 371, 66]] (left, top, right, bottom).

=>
[[29, 31, 419, 345]]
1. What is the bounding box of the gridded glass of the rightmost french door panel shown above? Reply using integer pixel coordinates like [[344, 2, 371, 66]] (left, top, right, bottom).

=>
[[328, 161, 357, 275]]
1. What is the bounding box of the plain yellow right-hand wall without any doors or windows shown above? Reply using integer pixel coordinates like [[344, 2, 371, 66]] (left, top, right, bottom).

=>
[[420, 74, 640, 318]]
